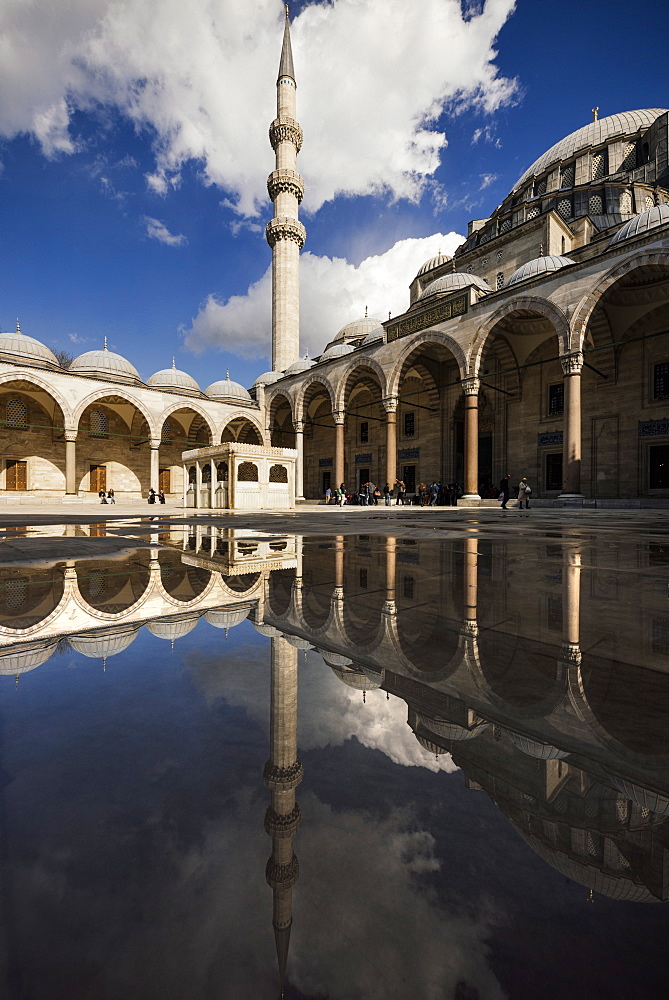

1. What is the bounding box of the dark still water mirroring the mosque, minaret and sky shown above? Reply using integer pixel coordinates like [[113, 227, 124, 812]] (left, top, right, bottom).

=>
[[0, 525, 669, 1000]]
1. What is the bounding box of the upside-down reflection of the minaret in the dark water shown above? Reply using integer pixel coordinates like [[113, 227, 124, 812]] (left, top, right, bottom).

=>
[[264, 637, 303, 995]]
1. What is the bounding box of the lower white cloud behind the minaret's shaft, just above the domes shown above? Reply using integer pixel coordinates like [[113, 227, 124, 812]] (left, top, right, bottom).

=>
[[185, 232, 464, 358]]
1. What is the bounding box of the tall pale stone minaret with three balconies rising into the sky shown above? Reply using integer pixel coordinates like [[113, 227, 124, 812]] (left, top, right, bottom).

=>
[[265, 4, 307, 371]]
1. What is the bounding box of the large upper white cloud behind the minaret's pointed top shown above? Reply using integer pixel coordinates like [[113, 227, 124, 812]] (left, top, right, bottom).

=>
[[0, 0, 516, 216]]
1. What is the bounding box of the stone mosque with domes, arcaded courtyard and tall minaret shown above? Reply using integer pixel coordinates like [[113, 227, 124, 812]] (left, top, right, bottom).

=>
[[0, 8, 669, 508]]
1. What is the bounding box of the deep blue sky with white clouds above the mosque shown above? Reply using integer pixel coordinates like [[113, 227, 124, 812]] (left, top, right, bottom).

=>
[[0, 0, 669, 388]]
